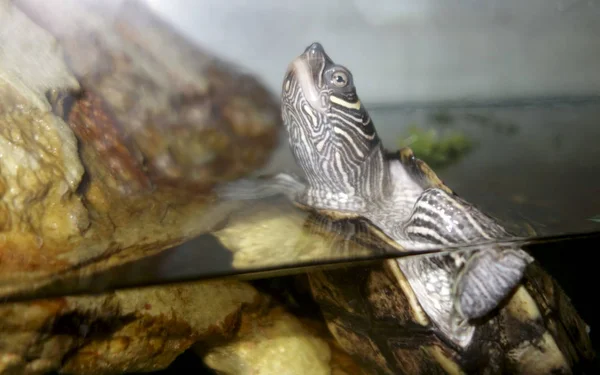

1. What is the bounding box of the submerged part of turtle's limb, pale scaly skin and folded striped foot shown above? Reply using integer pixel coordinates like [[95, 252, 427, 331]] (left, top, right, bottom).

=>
[[396, 245, 532, 348]]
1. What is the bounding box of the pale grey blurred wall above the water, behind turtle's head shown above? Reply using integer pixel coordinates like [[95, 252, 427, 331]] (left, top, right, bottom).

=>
[[147, 0, 600, 105]]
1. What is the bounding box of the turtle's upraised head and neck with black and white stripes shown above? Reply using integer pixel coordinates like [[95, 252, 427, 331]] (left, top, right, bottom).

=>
[[281, 43, 381, 203]]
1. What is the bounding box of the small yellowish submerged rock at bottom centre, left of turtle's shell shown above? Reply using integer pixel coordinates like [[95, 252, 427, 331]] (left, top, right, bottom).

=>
[[200, 307, 363, 375]]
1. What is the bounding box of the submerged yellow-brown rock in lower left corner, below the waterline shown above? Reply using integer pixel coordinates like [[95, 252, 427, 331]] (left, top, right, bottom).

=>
[[0, 281, 261, 374]]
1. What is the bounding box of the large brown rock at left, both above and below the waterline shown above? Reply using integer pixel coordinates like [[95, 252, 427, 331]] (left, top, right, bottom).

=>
[[0, 0, 296, 374]]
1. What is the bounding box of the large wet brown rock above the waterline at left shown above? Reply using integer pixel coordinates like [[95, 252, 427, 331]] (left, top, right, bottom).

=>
[[0, 0, 281, 296]]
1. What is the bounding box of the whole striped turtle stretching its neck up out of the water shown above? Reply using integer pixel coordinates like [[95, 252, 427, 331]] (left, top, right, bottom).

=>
[[218, 43, 595, 374]]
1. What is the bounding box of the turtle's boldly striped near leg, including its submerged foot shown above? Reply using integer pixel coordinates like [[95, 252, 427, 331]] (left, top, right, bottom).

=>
[[403, 188, 533, 320]]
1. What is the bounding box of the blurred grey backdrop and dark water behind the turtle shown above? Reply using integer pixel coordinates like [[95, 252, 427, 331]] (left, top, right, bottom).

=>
[[147, 0, 600, 234]]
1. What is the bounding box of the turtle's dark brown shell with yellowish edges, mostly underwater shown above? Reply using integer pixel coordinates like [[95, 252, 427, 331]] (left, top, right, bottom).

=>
[[302, 148, 595, 374]]
